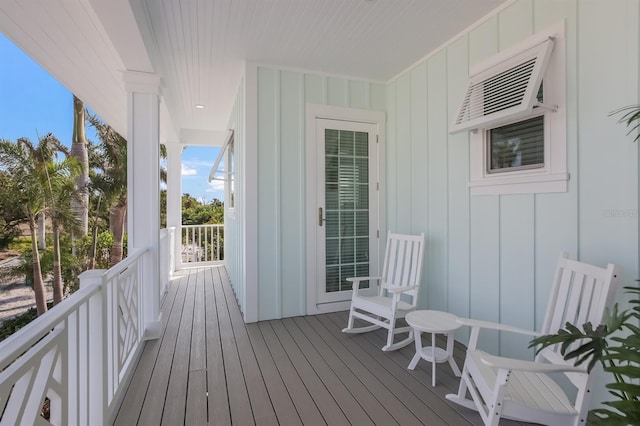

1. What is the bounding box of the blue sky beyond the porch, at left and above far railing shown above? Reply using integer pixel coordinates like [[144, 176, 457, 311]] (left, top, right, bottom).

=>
[[0, 34, 224, 202]]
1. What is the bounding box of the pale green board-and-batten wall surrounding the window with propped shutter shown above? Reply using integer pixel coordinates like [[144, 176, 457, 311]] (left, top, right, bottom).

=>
[[386, 0, 640, 357]]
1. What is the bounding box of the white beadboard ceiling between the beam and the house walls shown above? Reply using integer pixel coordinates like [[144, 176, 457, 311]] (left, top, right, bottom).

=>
[[131, 0, 504, 130]]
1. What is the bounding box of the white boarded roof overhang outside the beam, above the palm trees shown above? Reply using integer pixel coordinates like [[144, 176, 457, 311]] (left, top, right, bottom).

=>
[[0, 0, 126, 134]]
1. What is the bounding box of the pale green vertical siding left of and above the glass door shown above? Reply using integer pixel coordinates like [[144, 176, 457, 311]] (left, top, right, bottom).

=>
[[257, 66, 386, 320]]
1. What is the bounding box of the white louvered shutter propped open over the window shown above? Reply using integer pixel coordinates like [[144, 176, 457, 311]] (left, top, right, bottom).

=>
[[450, 38, 553, 133]]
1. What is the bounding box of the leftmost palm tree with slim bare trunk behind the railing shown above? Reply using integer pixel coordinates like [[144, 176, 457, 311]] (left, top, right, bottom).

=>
[[0, 139, 47, 315]]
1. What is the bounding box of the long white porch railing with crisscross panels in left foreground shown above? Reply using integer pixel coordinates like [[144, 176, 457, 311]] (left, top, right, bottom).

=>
[[0, 250, 151, 425]]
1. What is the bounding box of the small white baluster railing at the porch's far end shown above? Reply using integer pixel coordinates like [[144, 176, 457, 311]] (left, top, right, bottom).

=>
[[181, 224, 224, 264]]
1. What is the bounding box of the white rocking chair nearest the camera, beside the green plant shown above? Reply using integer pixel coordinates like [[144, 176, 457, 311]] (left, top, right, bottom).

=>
[[447, 253, 617, 426]]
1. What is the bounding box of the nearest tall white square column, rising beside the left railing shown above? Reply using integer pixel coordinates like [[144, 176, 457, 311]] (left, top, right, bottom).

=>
[[124, 71, 161, 339]]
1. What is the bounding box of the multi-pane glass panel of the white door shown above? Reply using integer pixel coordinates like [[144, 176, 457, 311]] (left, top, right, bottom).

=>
[[324, 129, 369, 292]]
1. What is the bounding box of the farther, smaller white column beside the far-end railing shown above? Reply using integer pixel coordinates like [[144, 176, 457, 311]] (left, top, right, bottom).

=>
[[165, 143, 183, 271]]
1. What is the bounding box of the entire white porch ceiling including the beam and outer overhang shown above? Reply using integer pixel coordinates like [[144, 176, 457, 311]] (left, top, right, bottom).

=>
[[0, 0, 506, 141]]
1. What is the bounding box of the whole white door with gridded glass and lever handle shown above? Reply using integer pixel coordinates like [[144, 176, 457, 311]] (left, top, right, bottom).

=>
[[308, 118, 380, 311]]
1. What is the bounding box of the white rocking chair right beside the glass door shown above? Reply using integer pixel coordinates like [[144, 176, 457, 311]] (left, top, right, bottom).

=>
[[342, 232, 424, 351]]
